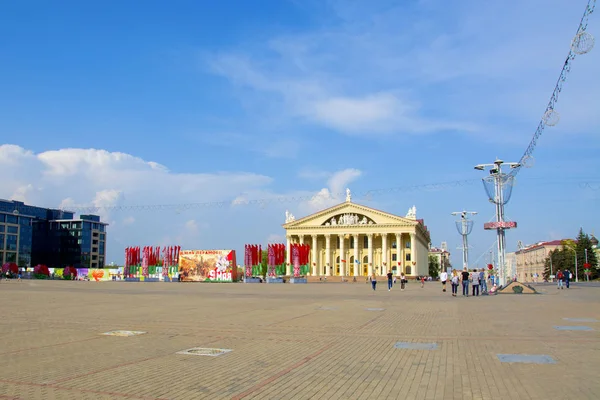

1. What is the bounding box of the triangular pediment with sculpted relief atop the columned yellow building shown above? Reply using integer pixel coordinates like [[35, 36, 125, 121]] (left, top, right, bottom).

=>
[[283, 202, 418, 229]]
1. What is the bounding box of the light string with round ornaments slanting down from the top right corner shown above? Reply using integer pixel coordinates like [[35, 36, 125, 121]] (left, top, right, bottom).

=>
[[510, 0, 596, 176]]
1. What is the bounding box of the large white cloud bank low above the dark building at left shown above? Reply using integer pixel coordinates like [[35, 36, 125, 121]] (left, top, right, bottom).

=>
[[0, 145, 272, 262]]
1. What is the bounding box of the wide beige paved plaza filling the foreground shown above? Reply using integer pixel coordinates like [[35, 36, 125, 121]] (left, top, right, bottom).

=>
[[0, 280, 600, 400]]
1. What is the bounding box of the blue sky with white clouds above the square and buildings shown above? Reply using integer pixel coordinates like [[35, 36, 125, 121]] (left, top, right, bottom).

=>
[[0, 0, 600, 265]]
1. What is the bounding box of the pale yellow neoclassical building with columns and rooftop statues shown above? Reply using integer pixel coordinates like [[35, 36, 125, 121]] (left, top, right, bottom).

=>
[[283, 189, 431, 277]]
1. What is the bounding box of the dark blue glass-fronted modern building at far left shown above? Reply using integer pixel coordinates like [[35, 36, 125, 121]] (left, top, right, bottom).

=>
[[0, 200, 107, 268]]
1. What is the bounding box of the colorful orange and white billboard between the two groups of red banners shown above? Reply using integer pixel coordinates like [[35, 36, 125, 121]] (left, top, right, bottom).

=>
[[179, 250, 237, 282]]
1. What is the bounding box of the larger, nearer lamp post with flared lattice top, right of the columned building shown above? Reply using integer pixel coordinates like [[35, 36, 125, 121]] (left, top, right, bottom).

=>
[[475, 159, 521, 286]]
